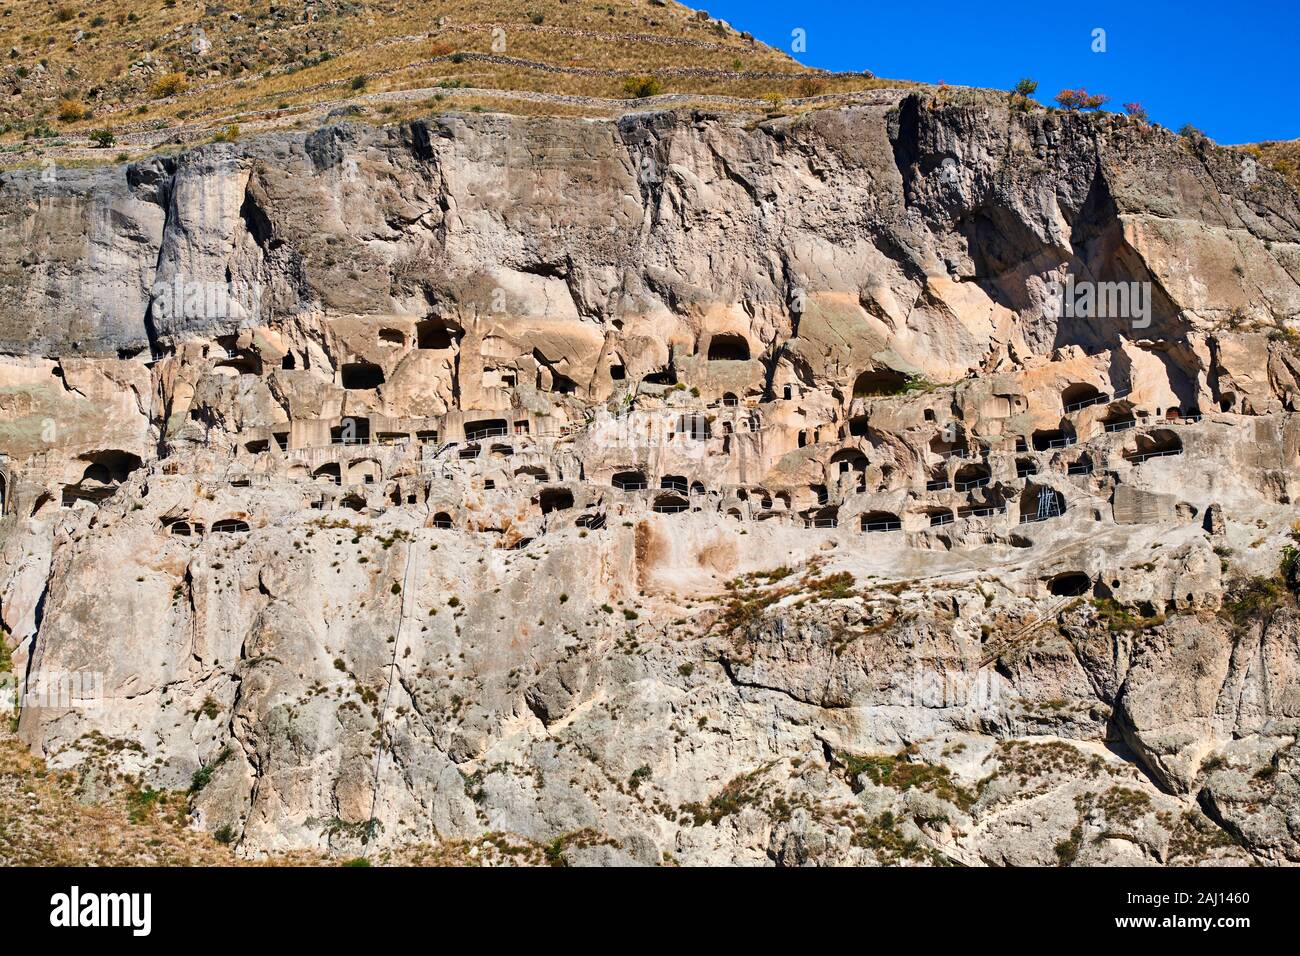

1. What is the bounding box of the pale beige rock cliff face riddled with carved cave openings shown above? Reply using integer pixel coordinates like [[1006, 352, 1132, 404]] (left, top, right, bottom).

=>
[[0, 90, 1300, 865]]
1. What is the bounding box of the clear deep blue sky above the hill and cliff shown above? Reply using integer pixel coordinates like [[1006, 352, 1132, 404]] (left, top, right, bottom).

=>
[[688, 0, 1300, 143]]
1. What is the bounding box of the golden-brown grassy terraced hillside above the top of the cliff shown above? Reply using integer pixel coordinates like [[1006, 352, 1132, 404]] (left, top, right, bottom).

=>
[[0, 0, 879, 164]]
